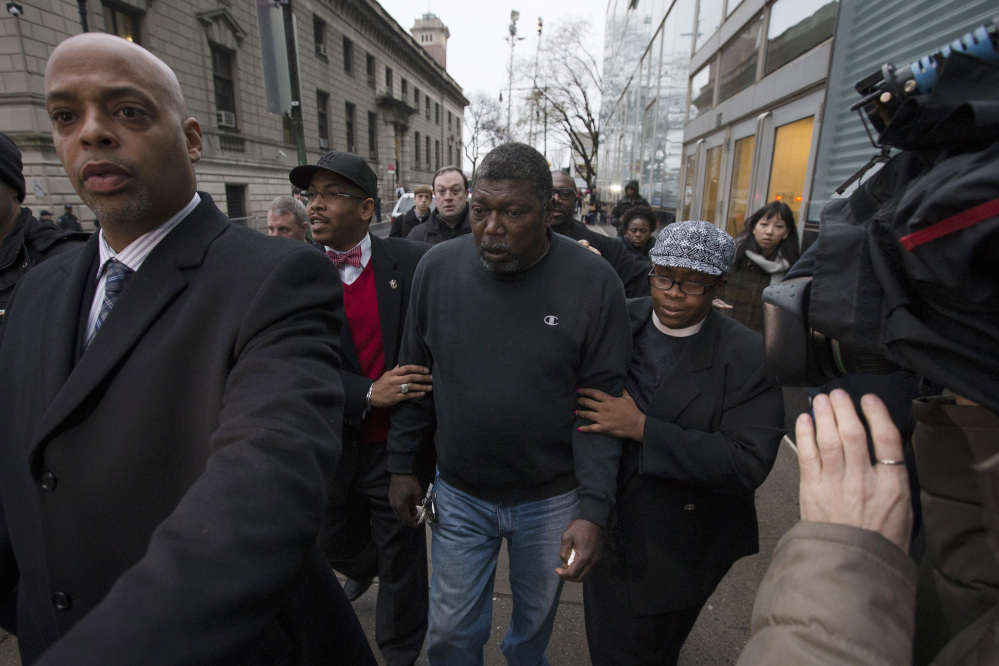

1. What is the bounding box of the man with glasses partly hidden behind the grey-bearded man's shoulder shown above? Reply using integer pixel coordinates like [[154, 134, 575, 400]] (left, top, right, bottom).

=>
[[551, 170, 652, 298]]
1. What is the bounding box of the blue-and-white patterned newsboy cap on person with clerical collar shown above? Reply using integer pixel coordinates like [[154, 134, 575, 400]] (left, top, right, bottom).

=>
[[649, 221, 735, 275]]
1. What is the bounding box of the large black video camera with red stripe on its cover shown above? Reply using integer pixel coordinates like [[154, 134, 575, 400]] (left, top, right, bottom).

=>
[[763, 16, 999, 412]]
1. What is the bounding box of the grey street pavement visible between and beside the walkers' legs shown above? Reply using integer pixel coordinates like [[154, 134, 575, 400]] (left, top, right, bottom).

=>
[[0, 222, 799, 666]]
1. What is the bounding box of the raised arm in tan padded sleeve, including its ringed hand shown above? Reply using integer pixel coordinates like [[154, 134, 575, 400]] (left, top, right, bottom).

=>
[[739, 390, 916, 666]]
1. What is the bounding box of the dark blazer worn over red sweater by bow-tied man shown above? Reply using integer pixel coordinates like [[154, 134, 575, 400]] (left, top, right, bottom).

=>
[[334, 234, 436, 501]]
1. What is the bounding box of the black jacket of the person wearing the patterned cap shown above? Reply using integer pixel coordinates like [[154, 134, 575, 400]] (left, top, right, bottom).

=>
[[607, 298, 784, 615]]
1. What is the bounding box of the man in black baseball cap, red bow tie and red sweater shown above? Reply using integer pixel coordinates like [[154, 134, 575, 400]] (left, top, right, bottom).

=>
[[289, 151, 434, 665]]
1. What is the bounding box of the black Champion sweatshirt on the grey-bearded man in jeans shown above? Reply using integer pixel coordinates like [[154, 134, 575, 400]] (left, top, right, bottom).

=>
[[388, 233, 631, 526]]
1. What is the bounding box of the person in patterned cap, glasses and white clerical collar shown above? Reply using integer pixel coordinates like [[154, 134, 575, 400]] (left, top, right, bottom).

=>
[[578, 222, 784, 664]]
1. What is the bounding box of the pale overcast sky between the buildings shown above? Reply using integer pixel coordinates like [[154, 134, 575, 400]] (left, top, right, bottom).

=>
[[378, 0, 607, 113]]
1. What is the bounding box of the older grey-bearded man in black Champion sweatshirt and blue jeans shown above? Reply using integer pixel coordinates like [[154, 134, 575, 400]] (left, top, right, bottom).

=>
[[388, 144, 631, 664]]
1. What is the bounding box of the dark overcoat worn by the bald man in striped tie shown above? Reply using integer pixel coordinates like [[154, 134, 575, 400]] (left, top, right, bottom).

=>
[[0, 193, 374, 665]]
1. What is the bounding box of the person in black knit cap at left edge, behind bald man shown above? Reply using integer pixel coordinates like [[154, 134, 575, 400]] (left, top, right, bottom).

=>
[[0, 132, 89, 321]]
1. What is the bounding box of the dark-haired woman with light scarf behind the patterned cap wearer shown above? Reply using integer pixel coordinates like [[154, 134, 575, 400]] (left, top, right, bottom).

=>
[[718, 201, 800, 333]]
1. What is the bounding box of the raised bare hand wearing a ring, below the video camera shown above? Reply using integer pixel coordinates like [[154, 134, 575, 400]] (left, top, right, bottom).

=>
[[795, 389, 912, 553]]
